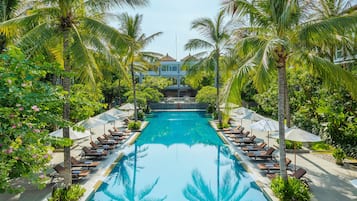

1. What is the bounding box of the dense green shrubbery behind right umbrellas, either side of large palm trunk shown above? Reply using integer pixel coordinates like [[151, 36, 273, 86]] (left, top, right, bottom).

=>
[[254, 68, 357, 158]]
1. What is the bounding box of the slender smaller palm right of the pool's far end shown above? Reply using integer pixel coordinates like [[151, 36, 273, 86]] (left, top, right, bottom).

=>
[[185, 12, 230, 128]]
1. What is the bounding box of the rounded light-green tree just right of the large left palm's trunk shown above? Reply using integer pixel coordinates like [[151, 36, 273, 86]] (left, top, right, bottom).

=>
[[70, 84, 106, 122]]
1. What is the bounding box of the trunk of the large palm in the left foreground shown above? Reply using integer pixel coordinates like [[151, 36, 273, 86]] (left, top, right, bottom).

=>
[[63, 28, 72, 186]]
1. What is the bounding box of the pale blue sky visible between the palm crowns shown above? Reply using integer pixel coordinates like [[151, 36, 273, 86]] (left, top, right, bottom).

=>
[[114, 0, 221, 60]]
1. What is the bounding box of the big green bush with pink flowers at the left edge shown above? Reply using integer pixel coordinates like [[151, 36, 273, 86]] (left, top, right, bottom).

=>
[[0, 48, 69, 192]]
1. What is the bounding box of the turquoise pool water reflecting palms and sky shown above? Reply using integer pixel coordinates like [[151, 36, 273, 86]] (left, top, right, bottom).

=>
[[90, 112, 267, 201]]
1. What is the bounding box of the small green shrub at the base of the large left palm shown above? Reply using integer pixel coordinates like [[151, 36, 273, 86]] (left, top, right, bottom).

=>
[[48, 184, 86, 201]]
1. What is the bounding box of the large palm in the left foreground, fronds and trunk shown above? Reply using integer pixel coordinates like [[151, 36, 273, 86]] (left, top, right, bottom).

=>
[[0, 0, 147, 185]]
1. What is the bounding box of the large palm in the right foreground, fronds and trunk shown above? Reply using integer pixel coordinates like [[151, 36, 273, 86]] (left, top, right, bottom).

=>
[[224, 0, 357, 181]]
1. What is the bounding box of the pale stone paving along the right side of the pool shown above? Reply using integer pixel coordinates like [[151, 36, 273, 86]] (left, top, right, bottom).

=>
[[210, 119, 357, 201]]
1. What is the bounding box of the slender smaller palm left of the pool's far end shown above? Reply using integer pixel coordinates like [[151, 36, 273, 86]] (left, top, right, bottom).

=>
[[119, 13, 162, 122]]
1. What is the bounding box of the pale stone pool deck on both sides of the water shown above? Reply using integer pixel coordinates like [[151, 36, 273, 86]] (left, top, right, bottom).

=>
[[0, 120, 357, 201]]
